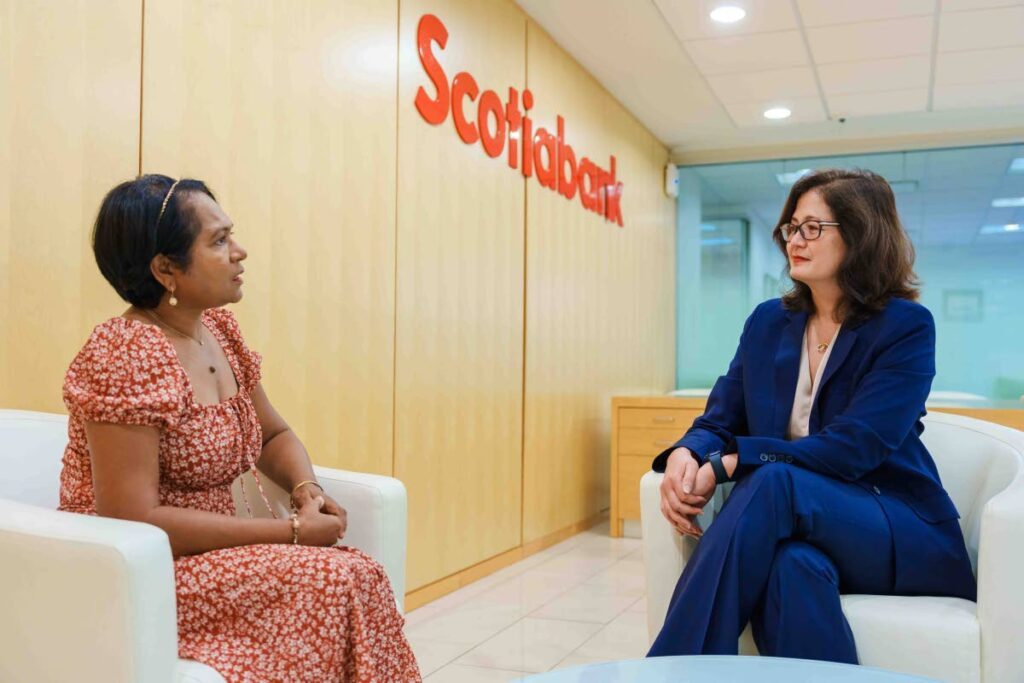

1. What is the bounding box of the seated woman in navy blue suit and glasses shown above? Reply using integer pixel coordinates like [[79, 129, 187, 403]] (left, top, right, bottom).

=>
[[648, 170, 976, 664]]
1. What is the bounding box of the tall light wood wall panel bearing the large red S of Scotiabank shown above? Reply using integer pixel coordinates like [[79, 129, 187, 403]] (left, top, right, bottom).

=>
[[395, 0, 528, 589]]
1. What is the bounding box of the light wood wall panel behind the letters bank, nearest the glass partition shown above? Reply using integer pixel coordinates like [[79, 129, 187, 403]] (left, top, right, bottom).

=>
[[523, 23, 675, 541]]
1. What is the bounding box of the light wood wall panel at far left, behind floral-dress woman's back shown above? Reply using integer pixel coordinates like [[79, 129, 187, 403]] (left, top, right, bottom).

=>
[[0, 0, 141, 412]]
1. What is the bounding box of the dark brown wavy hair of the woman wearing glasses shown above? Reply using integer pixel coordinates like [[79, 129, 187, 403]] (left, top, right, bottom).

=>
[[773, 169, 920, 324]]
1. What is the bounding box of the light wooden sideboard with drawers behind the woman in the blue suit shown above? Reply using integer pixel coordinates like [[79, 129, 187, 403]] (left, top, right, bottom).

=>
[[610, 396, 1024, 537]]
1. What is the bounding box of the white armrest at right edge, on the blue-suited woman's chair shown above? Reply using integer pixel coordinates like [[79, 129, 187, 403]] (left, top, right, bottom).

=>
[[978, 470, 1024, 683]]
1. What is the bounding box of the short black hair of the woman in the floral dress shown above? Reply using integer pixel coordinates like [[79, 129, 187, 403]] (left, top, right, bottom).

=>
[[92, 173, 217, 308]]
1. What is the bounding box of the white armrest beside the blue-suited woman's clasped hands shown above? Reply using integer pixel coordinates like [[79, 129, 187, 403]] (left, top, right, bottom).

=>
[[640, 471, 722, 642]]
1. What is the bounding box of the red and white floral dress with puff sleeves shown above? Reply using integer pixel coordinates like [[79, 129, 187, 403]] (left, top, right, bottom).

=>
[[60, 309, 420, 683]]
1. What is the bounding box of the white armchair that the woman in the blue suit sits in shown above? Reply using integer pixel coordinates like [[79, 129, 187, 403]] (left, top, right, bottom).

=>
[[640, 413, 1024, 683]]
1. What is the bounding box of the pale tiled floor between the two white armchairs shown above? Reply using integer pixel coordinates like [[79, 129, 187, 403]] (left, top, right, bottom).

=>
[[406, 523, 647, 683]]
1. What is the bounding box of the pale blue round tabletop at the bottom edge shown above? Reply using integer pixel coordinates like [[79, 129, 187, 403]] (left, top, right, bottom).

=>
[[521, 656, 938, 683]]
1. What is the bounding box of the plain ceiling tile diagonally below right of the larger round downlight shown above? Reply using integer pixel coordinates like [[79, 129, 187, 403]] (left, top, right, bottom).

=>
[[807, 16, 934, 65]]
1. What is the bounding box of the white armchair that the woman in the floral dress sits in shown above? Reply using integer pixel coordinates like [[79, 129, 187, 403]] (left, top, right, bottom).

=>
[[0, 410, 407, 683]]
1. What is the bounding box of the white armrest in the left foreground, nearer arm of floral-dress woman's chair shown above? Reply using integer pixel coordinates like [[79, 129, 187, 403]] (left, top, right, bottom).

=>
[[0, 499, 177, 683]]
